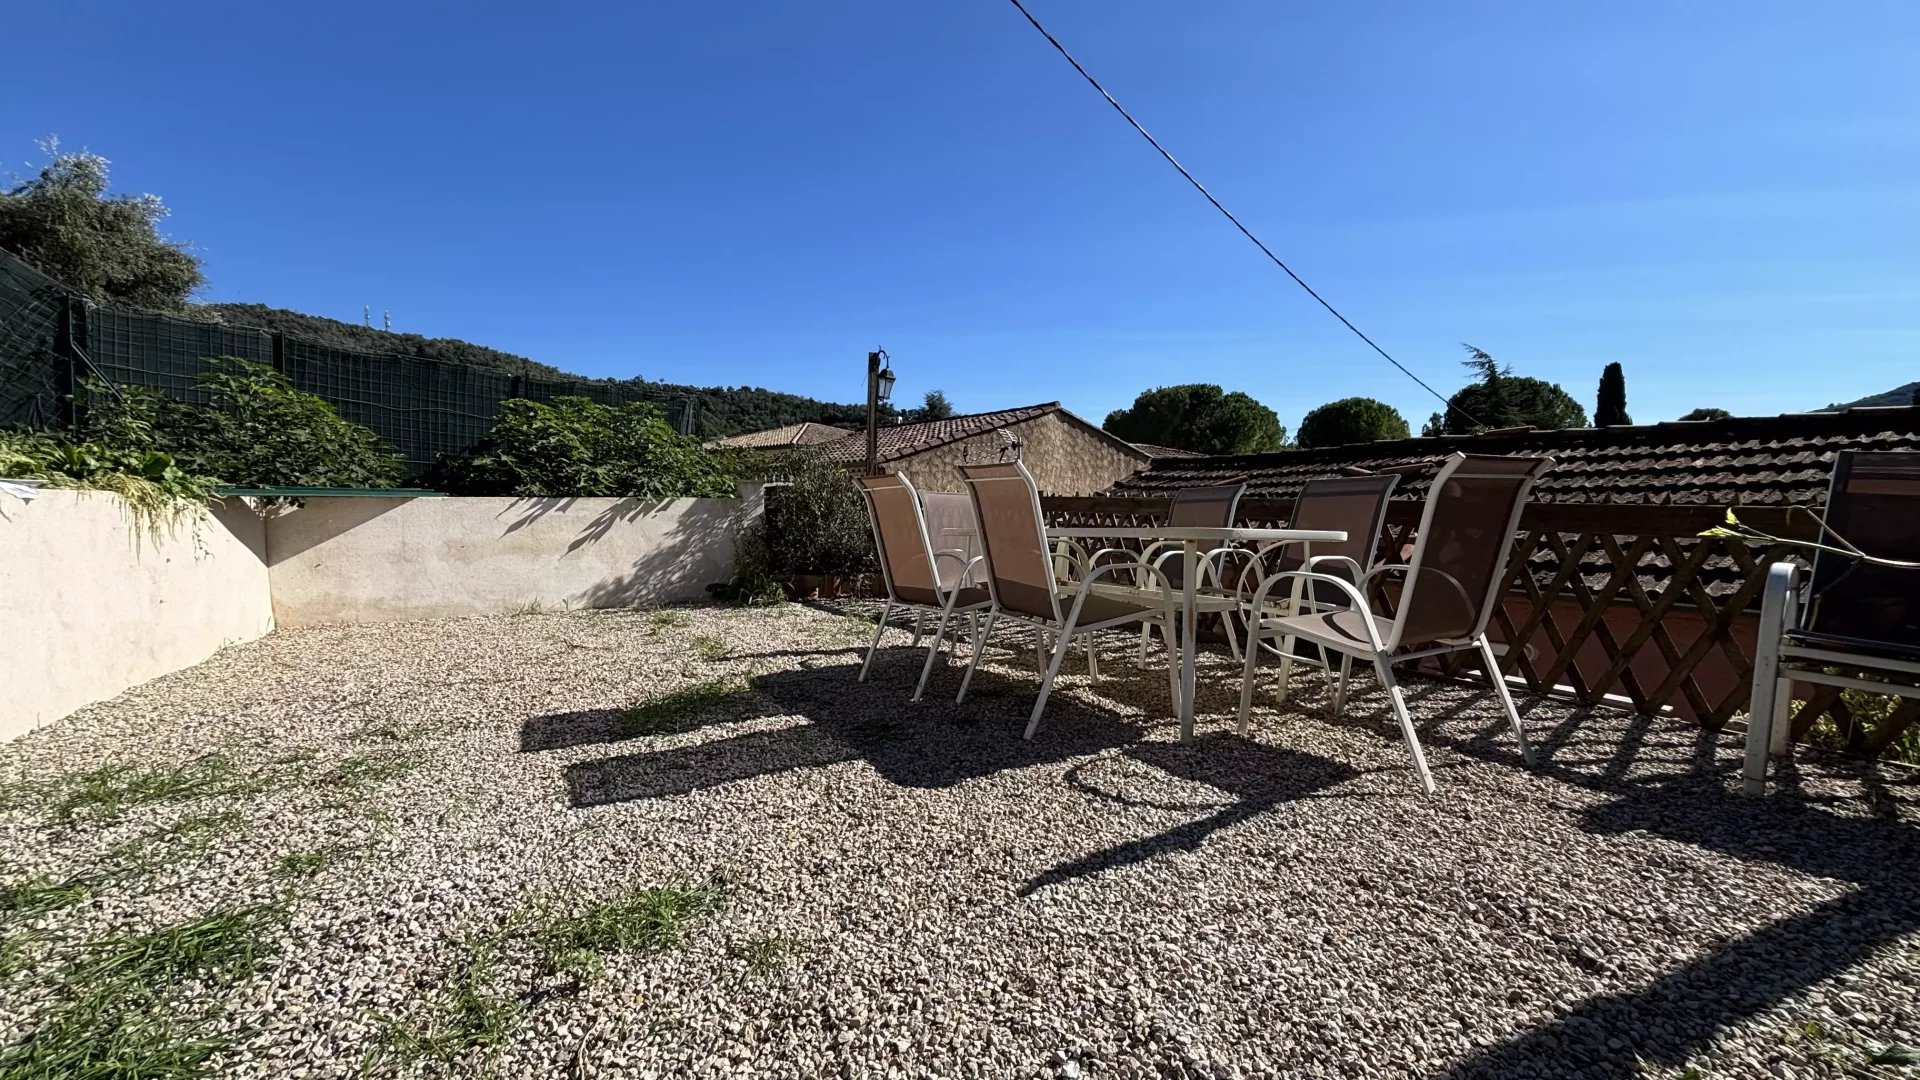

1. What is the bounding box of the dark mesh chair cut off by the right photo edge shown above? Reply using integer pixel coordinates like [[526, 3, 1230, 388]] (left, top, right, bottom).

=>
[[1741, 450, 1920, 796]]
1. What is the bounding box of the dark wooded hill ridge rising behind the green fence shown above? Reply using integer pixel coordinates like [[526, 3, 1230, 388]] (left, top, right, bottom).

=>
[[194, 304, 897, 438]]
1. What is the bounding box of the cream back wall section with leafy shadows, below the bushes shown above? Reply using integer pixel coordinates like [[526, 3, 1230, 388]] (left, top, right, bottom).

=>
[[267, 486, 762, 626]]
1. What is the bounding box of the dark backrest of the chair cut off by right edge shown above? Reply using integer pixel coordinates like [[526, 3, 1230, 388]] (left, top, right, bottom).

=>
[[1803, 450, 1920, 648]]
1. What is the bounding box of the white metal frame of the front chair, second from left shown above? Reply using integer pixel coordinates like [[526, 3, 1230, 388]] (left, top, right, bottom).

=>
[[954, 461, 1181, 740]]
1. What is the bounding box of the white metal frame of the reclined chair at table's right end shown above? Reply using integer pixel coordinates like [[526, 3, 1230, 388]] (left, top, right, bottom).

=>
[[1240, 454, 1534, 796]]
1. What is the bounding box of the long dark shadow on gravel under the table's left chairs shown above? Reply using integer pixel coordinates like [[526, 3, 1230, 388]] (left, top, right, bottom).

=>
[[566, 661, 1142, 807]]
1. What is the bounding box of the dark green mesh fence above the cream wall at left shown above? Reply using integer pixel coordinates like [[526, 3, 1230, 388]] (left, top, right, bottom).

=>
[[0, 252, 693, 475]]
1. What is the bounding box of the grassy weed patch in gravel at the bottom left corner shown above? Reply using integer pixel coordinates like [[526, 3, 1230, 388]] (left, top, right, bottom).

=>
[[0, 905, 286, 1080]]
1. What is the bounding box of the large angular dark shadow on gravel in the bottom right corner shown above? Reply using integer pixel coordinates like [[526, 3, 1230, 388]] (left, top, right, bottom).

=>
[[1382, 686, 1920, 1080]]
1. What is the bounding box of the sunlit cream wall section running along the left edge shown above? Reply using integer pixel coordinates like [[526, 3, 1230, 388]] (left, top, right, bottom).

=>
[[0, 492, 273, 740]]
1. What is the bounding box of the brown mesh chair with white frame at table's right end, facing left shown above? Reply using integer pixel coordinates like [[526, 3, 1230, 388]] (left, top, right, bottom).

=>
[[1240, 454, 1553, 796]]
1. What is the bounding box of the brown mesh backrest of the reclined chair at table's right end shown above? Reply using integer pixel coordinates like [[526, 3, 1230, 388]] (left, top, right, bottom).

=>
[[1386, 454, 1553, 648]]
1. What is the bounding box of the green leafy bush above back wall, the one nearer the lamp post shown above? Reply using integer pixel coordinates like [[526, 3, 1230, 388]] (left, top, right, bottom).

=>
[[428, 398, 735, 498]]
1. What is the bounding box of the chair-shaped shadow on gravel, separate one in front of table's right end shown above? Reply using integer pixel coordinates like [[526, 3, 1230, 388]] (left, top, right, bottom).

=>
[[1018, 734, 1361, 896]]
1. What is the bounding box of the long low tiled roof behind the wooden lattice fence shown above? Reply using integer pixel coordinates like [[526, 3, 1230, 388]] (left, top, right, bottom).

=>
[[1110, 407, 1920, 505]]
